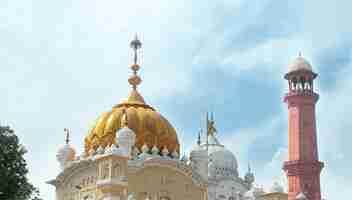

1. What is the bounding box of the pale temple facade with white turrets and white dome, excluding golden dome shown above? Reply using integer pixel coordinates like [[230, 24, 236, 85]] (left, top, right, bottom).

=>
[[49, 122, 281, 200]]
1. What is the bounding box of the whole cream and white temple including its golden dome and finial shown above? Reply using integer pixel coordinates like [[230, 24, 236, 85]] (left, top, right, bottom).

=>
[[48, 38, 310, 200]]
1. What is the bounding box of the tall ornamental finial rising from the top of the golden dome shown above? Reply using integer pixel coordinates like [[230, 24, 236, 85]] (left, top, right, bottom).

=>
[[128, 34, 142, 90]]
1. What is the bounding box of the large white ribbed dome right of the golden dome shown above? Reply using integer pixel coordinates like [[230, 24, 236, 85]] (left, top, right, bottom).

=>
[[208, 141, 238, 178]]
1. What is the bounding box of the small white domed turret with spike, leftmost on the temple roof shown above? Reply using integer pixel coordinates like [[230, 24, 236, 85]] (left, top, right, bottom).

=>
[[56, 128, 76, 169]]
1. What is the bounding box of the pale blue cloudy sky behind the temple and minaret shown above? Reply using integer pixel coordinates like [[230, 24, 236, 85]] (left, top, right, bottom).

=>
[[0, 0, 352, 200]]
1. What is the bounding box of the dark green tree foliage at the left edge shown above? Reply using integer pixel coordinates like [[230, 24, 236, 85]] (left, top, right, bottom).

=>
[[0, 126, 40, 200]]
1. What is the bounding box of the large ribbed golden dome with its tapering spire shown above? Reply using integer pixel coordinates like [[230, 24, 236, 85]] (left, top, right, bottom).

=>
[[84, 35, 180, 153]]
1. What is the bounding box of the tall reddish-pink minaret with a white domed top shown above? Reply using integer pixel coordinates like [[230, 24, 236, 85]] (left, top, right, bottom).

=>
[[283, 55, 324, 200]]
